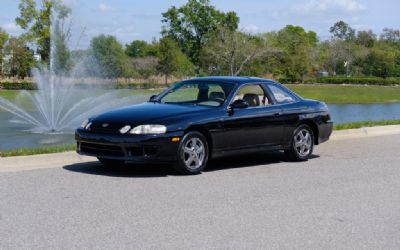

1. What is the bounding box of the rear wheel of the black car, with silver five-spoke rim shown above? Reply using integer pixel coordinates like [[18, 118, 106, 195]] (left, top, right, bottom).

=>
[[285, 124, 314, 161]]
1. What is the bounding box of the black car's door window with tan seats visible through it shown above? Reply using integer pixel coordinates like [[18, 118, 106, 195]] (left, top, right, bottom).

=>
[[233, 84, 271, 107]]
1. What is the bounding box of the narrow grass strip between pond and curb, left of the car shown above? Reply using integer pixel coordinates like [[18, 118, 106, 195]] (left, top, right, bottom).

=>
[[0, 144, 76, 157]]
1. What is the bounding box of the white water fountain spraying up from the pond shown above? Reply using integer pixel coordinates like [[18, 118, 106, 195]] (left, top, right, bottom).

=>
[[0, 5, 146, 133]]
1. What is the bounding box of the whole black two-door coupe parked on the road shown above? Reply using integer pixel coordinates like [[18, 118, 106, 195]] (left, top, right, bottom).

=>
[[75, 77, 332, 174]]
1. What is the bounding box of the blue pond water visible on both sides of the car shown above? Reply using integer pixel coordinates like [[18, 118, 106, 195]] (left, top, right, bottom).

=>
[[0, 103, 400, 150]]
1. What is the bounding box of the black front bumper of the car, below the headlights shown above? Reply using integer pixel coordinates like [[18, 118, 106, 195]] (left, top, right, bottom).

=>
[[75, 129, 183, 163]]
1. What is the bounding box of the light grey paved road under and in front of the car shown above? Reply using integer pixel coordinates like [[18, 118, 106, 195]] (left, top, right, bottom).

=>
[[0, 135, 400, 249]]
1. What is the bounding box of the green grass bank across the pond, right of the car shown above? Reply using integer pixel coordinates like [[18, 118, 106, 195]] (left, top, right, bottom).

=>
[[286, 84, 400, 104]]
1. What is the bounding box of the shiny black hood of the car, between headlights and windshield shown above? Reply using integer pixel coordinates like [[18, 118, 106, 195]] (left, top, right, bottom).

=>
[[92, 102, 210, 126]]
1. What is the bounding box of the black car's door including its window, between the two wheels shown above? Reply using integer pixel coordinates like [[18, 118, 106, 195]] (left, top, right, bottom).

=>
[[219, 84, 283, 149]]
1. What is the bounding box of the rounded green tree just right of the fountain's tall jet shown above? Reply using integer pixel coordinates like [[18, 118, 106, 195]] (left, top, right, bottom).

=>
[[90, 35, 127, 78]]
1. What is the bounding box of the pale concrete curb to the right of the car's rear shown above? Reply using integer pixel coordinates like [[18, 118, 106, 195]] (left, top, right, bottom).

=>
[[330, 125, 400, 141]]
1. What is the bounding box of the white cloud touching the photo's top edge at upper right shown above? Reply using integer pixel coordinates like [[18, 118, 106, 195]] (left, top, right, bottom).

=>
[[291, 0, 366, 13]]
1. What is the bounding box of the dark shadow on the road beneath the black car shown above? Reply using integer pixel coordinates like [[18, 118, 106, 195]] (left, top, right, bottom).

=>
[[63, 152, 319, 178]]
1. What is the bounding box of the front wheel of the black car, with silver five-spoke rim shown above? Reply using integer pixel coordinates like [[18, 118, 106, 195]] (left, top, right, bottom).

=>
[[173, 131, 209, 175]]
